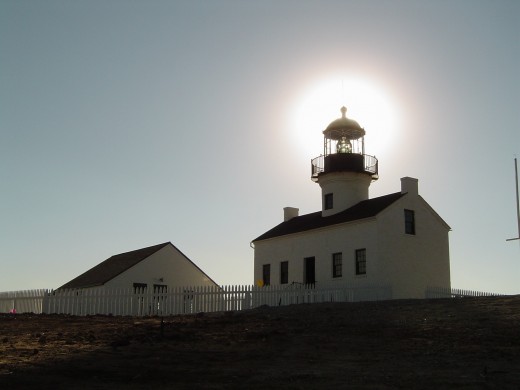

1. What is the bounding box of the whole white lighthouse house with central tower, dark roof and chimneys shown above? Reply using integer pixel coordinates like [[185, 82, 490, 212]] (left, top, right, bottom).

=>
[[252, 107, 450, 299]]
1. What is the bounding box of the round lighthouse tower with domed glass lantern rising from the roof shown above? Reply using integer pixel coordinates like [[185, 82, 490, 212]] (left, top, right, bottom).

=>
[[311, 107, 378, 217]]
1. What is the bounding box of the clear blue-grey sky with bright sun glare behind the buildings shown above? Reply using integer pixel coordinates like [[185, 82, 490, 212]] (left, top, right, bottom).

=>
[[0, 0, 520, 293]]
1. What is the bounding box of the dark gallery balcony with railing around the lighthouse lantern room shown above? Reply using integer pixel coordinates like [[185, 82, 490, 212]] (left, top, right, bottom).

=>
[[311, 153, 379, 181]]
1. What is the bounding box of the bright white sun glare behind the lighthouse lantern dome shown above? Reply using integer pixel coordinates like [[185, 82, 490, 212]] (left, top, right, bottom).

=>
[[289, 76, 399, 158]]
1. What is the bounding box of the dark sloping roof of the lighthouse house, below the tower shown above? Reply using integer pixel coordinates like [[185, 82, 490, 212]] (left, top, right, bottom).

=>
[[253, 192, 404, 242]]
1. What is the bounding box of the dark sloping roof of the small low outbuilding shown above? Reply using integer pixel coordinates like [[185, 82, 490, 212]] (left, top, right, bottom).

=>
[[60, 242, 171, 289]]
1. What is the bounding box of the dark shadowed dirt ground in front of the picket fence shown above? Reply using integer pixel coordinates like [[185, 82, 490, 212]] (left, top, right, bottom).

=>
[[0, 296, 520, 389]]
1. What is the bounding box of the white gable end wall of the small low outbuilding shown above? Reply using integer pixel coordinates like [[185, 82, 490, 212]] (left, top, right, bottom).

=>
[[105, 244, 216, 289]]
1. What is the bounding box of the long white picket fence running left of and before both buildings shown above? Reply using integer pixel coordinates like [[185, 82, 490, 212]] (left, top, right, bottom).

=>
[[0, 283, 392, 316]]
